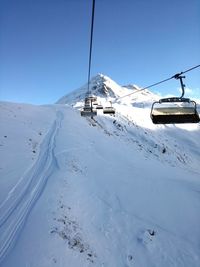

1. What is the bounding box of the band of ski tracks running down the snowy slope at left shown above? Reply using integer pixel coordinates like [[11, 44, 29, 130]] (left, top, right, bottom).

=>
[[0, 112, 63, 262]]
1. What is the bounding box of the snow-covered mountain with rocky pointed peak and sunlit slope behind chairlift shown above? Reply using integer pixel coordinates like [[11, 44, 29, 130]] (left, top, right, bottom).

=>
[[57, 74, 200, 172]]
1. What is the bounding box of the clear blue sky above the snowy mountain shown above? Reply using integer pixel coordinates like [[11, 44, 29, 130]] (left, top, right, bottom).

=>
[[0, 0, 200, 104]]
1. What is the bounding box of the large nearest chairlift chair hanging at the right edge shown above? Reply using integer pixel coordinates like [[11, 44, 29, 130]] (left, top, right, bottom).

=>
[[150, 74, 200, 124]]
